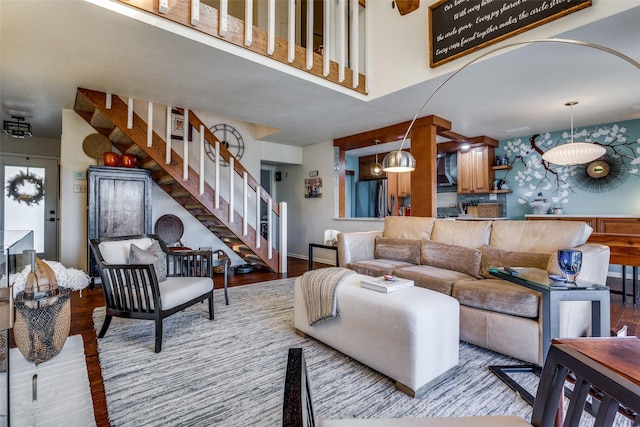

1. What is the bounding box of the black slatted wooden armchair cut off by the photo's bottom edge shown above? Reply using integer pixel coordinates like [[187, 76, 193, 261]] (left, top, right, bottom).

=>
[[282, 344, 640, 427]]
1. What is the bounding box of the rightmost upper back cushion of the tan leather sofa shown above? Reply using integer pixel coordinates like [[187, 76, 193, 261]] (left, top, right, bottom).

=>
[[489, 220, 593, 254]]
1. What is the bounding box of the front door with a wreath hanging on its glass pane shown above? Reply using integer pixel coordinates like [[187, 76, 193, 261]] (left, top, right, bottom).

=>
[[0, 155, 59, 261]]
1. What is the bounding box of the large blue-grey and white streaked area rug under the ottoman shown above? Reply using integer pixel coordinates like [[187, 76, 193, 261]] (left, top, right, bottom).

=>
[[94, 279, 632, 426]]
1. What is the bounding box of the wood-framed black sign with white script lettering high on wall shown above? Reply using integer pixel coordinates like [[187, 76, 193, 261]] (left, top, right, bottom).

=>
[[429, 0, 591, 67]]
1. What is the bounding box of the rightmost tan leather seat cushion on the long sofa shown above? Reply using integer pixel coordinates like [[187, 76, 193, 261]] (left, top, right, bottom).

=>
[[451, 279, 540, 319]]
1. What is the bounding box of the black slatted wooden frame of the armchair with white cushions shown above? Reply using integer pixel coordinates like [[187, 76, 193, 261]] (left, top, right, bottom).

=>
[[89, 234, 214, 353]]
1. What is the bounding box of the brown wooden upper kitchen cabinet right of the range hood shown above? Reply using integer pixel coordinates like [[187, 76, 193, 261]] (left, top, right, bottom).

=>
[[458, 146, 495, 194]]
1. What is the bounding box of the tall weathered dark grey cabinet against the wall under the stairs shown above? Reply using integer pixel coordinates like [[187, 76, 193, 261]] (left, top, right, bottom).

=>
[[87, 166, 152, 278]]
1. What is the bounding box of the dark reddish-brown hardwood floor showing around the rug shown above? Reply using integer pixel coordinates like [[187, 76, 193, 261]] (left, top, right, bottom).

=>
[[36, 258, 640, 426]]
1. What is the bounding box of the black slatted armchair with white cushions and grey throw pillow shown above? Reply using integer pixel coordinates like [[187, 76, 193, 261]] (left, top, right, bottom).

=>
[[89, 234, 214, 353]]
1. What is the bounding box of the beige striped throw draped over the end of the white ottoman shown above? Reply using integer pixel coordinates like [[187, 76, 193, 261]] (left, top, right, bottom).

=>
[[300, 267, 355, 326]]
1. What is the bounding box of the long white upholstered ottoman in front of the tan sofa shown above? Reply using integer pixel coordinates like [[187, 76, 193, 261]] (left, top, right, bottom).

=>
[[295, 274, 460, 397]]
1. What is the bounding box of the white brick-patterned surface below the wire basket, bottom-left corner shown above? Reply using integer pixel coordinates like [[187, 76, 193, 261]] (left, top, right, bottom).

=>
[[0, 335, 96, 427]]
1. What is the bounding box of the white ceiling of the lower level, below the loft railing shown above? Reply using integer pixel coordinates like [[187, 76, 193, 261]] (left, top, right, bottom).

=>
[[0, 0, 640, 153]]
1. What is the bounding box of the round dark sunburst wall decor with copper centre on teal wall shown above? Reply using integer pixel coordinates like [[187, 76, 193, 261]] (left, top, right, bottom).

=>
[[573, 152, 629, 193]]
